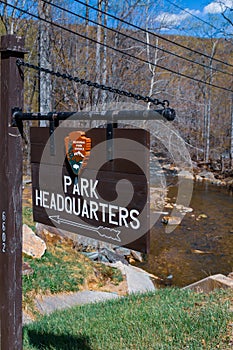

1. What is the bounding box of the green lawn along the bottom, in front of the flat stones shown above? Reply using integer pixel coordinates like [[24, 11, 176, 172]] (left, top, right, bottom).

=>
[[24, 289, 231, 350]]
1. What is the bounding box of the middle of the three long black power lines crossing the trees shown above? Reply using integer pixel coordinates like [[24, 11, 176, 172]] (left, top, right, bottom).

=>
[[42, 0, 233, 76]]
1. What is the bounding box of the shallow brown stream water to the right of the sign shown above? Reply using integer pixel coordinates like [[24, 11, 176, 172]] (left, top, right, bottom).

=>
[[138, 182, 233, 287]]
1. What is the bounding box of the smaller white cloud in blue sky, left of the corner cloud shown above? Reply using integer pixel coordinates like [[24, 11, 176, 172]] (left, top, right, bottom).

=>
[[155, 8, 200, 26]]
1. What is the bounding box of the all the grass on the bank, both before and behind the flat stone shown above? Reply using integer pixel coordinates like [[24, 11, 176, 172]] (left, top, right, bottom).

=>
[[23, 198, 233, 350]]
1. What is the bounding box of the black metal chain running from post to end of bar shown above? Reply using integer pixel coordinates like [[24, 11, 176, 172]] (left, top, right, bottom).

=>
[[16, 59, 169, 108]]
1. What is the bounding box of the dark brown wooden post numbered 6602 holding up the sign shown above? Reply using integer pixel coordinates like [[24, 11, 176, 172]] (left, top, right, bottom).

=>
[[0, 35, 24, 350]]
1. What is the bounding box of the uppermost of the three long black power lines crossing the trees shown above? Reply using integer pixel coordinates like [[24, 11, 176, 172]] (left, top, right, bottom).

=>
[[74, 0, 233, 67]]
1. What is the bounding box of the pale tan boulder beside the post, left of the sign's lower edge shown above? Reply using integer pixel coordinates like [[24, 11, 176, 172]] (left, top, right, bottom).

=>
[[23, 224, 46, 259]]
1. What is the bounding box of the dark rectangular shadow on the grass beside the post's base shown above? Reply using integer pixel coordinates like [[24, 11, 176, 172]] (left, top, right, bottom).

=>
[[24, 330, 93, 350]]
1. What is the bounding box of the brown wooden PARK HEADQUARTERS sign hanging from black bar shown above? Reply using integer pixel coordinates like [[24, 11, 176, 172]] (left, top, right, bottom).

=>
[[31, 127, 149, 252]]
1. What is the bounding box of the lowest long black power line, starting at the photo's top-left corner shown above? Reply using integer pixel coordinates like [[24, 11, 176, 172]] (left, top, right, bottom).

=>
[[0, 0, 232, 92]]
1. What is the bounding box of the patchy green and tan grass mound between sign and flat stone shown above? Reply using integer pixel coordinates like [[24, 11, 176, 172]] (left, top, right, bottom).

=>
[[23, 245, 123, 295]]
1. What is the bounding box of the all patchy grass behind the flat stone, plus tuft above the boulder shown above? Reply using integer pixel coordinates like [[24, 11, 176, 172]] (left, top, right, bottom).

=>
[[23, 207, 123, 317]]
